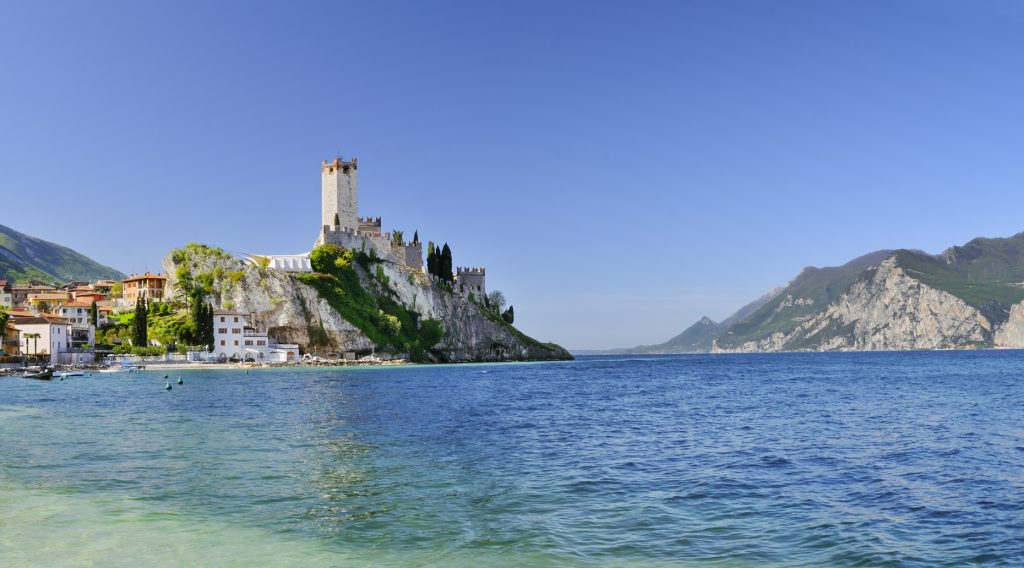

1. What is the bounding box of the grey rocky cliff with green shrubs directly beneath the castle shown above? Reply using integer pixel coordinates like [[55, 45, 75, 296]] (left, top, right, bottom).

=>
[[164, 245, 571, 362]]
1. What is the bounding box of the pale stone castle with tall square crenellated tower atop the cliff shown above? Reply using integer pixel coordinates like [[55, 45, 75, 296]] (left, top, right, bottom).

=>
[[250, 157, 486, 297]]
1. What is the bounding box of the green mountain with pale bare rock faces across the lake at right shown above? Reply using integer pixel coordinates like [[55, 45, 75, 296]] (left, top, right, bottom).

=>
[[638, 233, 1024, 352]]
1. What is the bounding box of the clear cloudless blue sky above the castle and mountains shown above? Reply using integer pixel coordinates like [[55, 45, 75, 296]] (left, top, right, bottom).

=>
[[0, 0, 1024, 348]]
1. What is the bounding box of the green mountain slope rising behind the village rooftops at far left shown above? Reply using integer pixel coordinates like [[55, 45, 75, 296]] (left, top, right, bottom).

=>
[[0, 225, 125, 283]]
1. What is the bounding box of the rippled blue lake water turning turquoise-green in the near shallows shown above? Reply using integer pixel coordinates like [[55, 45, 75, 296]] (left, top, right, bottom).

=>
[[0, 351, 1024, 566]]
